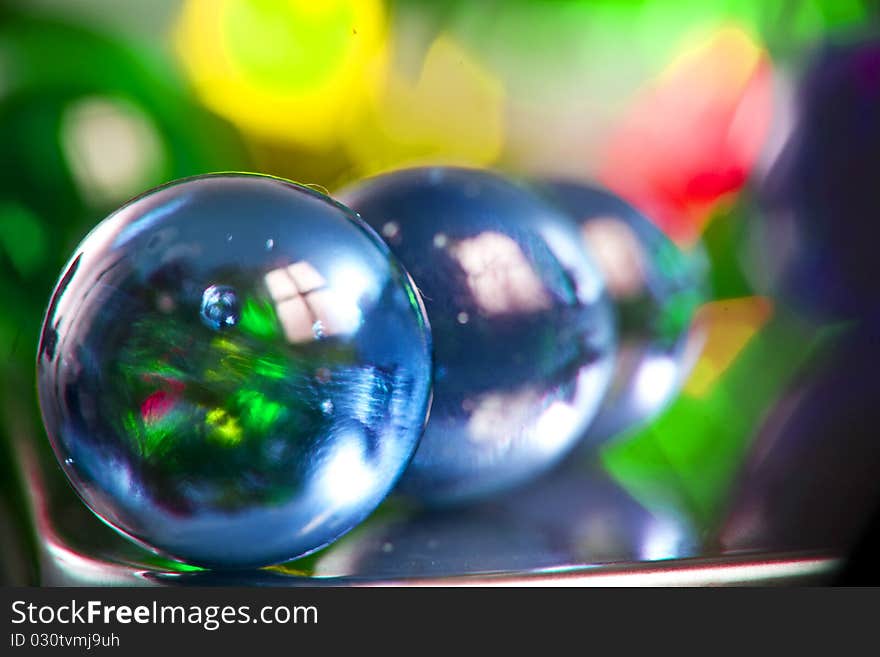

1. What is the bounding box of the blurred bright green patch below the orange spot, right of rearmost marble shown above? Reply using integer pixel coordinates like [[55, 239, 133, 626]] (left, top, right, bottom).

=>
[[603, 316, 830, 535]]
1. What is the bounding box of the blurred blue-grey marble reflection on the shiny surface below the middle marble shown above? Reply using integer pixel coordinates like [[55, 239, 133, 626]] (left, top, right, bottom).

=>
[[314, 462, 700, 578]]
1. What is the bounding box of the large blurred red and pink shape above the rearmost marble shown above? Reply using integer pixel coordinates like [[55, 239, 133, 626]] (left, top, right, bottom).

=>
[[600, 26, 772, 244]]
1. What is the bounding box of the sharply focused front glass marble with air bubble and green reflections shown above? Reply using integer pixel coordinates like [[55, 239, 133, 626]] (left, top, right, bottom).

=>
[[37, 174, 431, 568]]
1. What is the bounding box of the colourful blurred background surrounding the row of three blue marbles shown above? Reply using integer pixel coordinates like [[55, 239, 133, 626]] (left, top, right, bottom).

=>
[[0, 0, 880, 583]]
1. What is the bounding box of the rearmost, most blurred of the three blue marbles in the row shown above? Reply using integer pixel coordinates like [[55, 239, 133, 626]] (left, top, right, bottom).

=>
[[543, 181, 708, 446]]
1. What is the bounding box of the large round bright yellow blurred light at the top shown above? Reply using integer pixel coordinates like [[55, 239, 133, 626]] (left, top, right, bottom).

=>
[[174, 0, 387, 149]]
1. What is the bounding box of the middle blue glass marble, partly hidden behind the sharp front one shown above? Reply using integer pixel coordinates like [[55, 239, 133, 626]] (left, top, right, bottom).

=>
[[340, 167, 614, 505]]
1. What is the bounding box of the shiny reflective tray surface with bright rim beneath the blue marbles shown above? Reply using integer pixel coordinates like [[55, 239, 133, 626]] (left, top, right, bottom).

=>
[[10, 408, 839, 586]]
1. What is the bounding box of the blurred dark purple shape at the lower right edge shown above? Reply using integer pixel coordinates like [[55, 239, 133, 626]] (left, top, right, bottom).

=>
[[720, 330, 880, 551]]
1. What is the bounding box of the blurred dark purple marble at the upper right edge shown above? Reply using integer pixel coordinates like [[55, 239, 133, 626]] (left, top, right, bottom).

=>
[[748, 36, 880, 327]]
